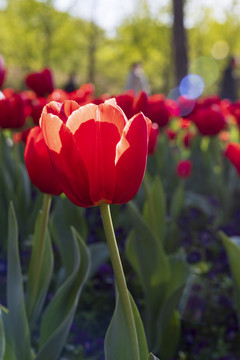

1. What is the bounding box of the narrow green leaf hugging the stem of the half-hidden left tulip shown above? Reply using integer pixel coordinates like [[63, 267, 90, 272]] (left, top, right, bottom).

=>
[[26, 211, 53, 328]]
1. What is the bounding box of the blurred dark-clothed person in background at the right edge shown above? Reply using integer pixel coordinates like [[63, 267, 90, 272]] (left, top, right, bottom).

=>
[[220, 56, 239, 101]]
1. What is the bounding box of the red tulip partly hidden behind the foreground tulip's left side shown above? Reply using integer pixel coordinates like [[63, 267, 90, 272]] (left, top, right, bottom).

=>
[[24, 126, 62, 195]]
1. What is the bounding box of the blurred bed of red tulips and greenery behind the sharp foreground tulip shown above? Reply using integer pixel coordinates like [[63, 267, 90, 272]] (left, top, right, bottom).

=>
[[0, 62, 240, 360]]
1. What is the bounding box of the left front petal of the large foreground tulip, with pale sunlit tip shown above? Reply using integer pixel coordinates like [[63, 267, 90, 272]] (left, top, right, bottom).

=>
[[41, 114, 93, 207]]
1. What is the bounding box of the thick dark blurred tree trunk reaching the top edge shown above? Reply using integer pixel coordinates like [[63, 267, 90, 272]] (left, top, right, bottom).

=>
[[172, 0, 188, 85]]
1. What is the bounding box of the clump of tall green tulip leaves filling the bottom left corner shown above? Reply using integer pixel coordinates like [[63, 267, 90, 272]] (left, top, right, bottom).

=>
[[0, 203, 90, 360]]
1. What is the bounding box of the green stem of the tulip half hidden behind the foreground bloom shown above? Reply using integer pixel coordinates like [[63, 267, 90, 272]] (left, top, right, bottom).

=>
[[27, 194, 52, 318]]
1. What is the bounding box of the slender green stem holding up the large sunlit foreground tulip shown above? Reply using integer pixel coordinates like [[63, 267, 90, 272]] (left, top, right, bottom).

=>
[[99, 203, 140, 360]]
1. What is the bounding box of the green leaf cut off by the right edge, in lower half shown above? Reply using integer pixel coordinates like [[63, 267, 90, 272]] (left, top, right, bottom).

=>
[[219, 232, 240, 320]]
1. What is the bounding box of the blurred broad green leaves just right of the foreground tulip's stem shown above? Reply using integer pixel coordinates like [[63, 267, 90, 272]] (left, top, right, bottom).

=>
[[126, 201, 189, 359]]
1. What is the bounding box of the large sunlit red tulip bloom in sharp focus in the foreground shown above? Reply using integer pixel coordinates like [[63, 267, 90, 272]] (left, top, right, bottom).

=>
[[40, 99, 151, 207]]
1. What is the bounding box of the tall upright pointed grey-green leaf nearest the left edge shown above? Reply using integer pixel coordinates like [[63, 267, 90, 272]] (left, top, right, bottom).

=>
[[3, 203, 31, 360]]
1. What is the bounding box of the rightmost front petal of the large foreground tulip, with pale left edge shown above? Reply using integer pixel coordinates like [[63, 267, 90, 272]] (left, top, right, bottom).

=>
[[112, 113, 148, 204]]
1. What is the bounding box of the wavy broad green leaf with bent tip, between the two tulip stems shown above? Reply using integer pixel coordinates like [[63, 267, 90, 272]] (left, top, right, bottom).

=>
[[35, 228, 90, 360]]
